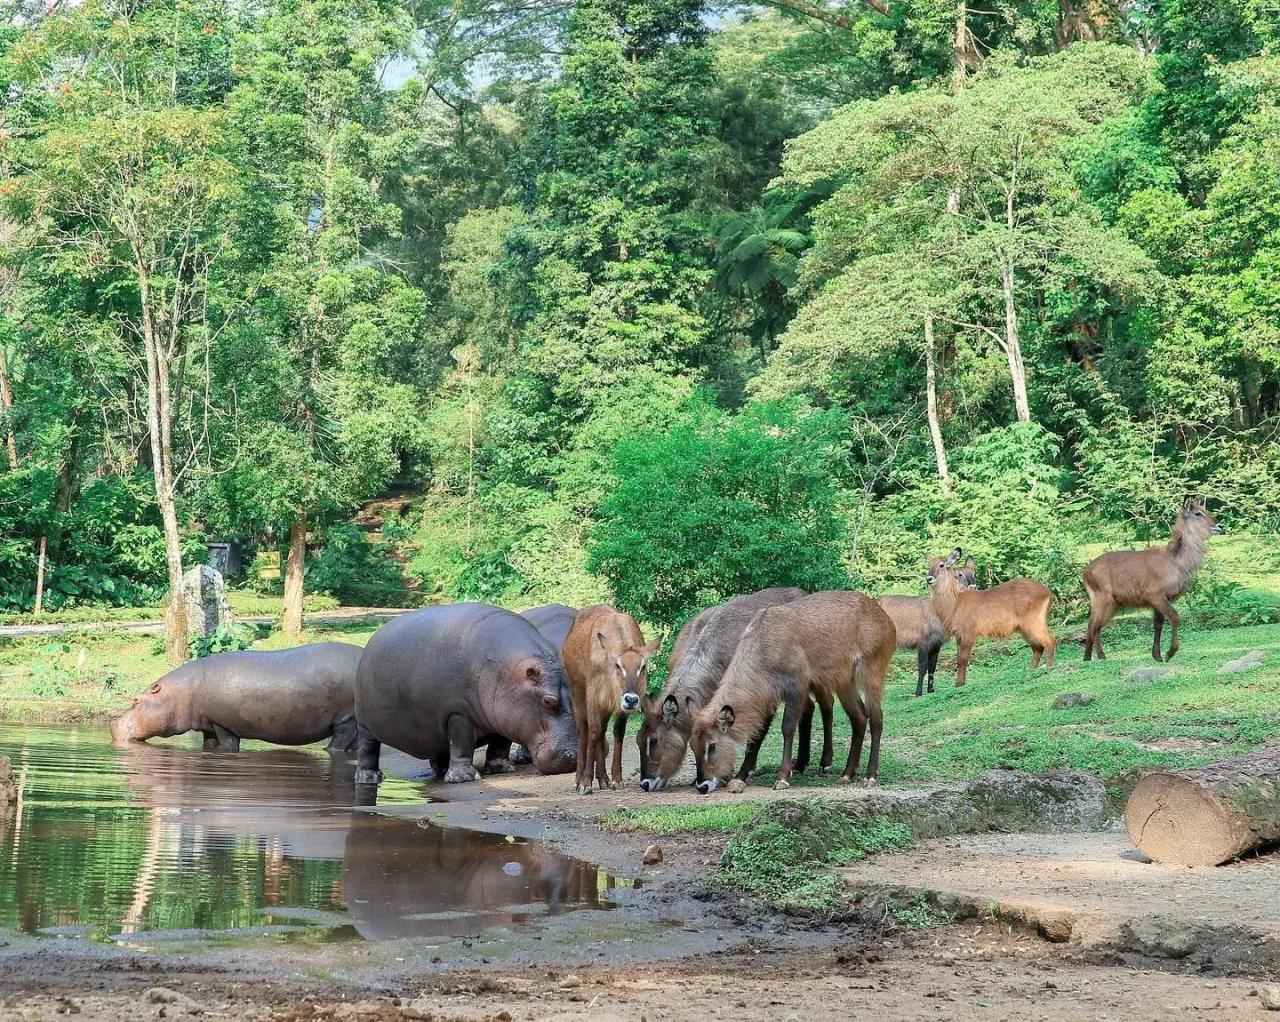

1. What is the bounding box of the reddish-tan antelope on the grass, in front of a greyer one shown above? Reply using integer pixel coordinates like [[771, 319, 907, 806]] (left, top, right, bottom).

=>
[[924, 547, 1057, 688]]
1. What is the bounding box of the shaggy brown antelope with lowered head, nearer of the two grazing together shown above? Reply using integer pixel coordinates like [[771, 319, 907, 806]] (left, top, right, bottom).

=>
[[690, 592, 897, 794]]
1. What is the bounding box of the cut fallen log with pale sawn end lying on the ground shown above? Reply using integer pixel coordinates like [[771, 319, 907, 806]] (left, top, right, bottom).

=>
[[1124, 745, 1280, 866]]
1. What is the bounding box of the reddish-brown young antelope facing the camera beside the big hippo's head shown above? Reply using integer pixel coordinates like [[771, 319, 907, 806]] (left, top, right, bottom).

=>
[[562, 603, 662, 795]]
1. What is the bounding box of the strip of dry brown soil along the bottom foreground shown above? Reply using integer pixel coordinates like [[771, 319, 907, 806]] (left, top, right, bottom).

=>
[[0, 925, 1260, 1022]]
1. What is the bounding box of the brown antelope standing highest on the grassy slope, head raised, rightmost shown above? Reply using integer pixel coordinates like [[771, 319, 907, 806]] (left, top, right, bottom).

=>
[[1084, 499, 1222, 661]]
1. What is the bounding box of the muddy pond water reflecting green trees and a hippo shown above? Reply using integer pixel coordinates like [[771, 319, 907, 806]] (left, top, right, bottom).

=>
[[0, 725, 628, 945]]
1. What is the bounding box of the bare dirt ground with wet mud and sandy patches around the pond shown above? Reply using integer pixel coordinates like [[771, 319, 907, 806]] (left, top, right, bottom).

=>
[[0, 747, 1280, 1022]]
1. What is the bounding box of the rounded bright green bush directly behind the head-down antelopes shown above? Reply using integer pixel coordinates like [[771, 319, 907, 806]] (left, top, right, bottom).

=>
[[588, 402, 847, 626]]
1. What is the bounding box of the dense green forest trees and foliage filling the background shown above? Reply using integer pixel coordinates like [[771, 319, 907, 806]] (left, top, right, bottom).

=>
[[0, 0, 1280, 626]]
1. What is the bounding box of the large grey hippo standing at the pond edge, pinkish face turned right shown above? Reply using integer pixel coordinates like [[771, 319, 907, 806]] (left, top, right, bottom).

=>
[[356, 603, 577, 784]]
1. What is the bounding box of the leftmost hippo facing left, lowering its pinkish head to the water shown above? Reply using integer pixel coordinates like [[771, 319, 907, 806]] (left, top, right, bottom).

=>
[[111, 643, 362, 752]]
